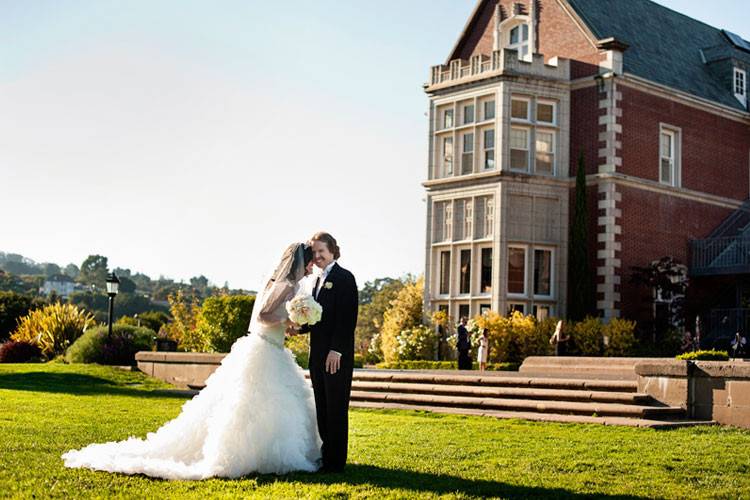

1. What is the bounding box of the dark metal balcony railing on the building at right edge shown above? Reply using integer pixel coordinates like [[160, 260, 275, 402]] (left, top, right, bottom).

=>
[[690, 237, 750, 276]]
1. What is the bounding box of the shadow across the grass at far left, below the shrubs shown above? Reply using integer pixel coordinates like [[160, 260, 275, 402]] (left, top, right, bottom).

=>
[[0, 372, 189, 399]]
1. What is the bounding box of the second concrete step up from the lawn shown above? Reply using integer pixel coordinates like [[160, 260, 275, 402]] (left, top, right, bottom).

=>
[[351, 390, 684, 419]]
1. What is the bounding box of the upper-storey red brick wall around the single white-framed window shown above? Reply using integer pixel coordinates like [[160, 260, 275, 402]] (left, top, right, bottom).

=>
[[618, 85, 750, 200]]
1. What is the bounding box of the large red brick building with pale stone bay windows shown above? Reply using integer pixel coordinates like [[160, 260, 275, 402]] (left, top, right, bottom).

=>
[[424, 0, 750, 340]]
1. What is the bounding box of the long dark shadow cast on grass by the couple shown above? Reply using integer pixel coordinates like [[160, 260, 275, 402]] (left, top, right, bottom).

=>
[[257, 464, 647, 500]]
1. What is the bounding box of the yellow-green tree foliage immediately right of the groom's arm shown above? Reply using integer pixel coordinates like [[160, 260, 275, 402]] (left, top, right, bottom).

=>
[[354, 278, 409, 355]]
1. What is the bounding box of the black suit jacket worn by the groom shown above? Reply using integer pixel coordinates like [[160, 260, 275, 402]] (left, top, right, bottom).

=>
[[302, 263, 359, 369]]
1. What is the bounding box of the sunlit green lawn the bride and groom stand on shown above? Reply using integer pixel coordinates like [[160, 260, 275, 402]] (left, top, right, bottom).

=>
[[0, 363, 750, 499]]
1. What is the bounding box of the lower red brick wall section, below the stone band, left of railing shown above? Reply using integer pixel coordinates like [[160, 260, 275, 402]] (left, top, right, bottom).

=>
[[617, 185, 732, 319]]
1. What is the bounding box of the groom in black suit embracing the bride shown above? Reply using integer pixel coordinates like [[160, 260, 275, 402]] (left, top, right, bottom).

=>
[[300, 232, 359, 472]]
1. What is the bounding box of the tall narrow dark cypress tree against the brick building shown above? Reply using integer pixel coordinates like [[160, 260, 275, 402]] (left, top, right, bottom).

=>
[[568, 152, 595, 321]]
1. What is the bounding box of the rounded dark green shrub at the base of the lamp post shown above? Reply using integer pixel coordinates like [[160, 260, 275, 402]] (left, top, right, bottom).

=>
[[65, 325, 155, 365]]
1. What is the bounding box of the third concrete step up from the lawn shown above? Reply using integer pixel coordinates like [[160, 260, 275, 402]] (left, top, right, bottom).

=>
[[352, 379, 654, 404]]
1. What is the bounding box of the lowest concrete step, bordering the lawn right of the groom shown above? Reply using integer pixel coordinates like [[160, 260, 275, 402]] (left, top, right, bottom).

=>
[[349, 401, 716, 429]]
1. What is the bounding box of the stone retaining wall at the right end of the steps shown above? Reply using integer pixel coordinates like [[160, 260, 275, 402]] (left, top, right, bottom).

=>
[[635, 360, 750, 428]]
